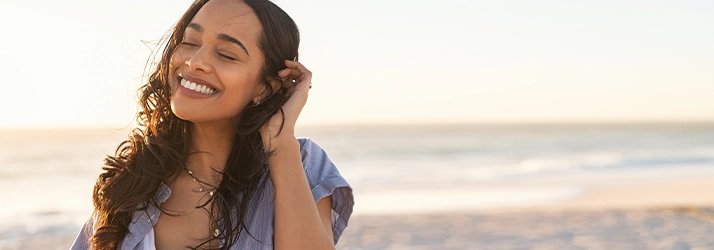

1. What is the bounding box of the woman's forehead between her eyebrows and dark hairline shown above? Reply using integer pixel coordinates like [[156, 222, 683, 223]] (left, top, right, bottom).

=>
[[191, 0, 262, 45]]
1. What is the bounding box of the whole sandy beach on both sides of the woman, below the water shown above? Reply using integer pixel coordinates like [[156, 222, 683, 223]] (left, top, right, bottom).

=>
[[5, 176, 714, 249]]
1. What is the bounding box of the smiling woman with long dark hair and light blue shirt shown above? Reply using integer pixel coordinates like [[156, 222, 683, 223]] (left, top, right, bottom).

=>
[[72, 0, 354, 249]]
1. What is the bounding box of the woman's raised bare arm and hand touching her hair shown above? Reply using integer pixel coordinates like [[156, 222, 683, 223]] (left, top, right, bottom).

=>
[[260, 60, 335, 250]]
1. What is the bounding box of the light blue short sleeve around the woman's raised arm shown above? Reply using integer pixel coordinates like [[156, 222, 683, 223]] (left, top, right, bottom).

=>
[[300, 138, 355, 245]]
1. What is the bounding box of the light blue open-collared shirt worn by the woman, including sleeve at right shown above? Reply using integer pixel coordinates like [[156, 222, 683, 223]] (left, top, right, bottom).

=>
[[71, 138, 354, 250]]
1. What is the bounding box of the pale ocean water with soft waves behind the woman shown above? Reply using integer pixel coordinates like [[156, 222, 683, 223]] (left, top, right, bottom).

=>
[[0, 123, 714, 249]]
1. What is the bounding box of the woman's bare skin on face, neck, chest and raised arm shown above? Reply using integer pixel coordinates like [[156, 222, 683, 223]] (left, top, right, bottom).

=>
[[154, 0, 334, 249]]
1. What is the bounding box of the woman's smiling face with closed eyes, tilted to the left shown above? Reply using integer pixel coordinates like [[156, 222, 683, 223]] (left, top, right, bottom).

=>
[[169, 0, 264, 123]]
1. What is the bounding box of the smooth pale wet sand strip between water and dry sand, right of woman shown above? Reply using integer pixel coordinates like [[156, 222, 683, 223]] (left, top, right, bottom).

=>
[[354, 171, 714, 216]]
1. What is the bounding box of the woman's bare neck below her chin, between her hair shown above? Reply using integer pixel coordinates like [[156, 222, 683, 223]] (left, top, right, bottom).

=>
[[186, 123, 235, 183]]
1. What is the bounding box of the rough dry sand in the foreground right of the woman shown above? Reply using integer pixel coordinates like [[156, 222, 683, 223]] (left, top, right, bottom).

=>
[[338, 207, 714, 250]]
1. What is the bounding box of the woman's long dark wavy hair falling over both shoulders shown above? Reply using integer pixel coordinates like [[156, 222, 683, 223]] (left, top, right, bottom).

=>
[[90, 0, 300, 249]]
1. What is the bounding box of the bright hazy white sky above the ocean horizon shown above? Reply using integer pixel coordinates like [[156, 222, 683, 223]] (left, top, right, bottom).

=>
[[0, 0, 714, 128]]
